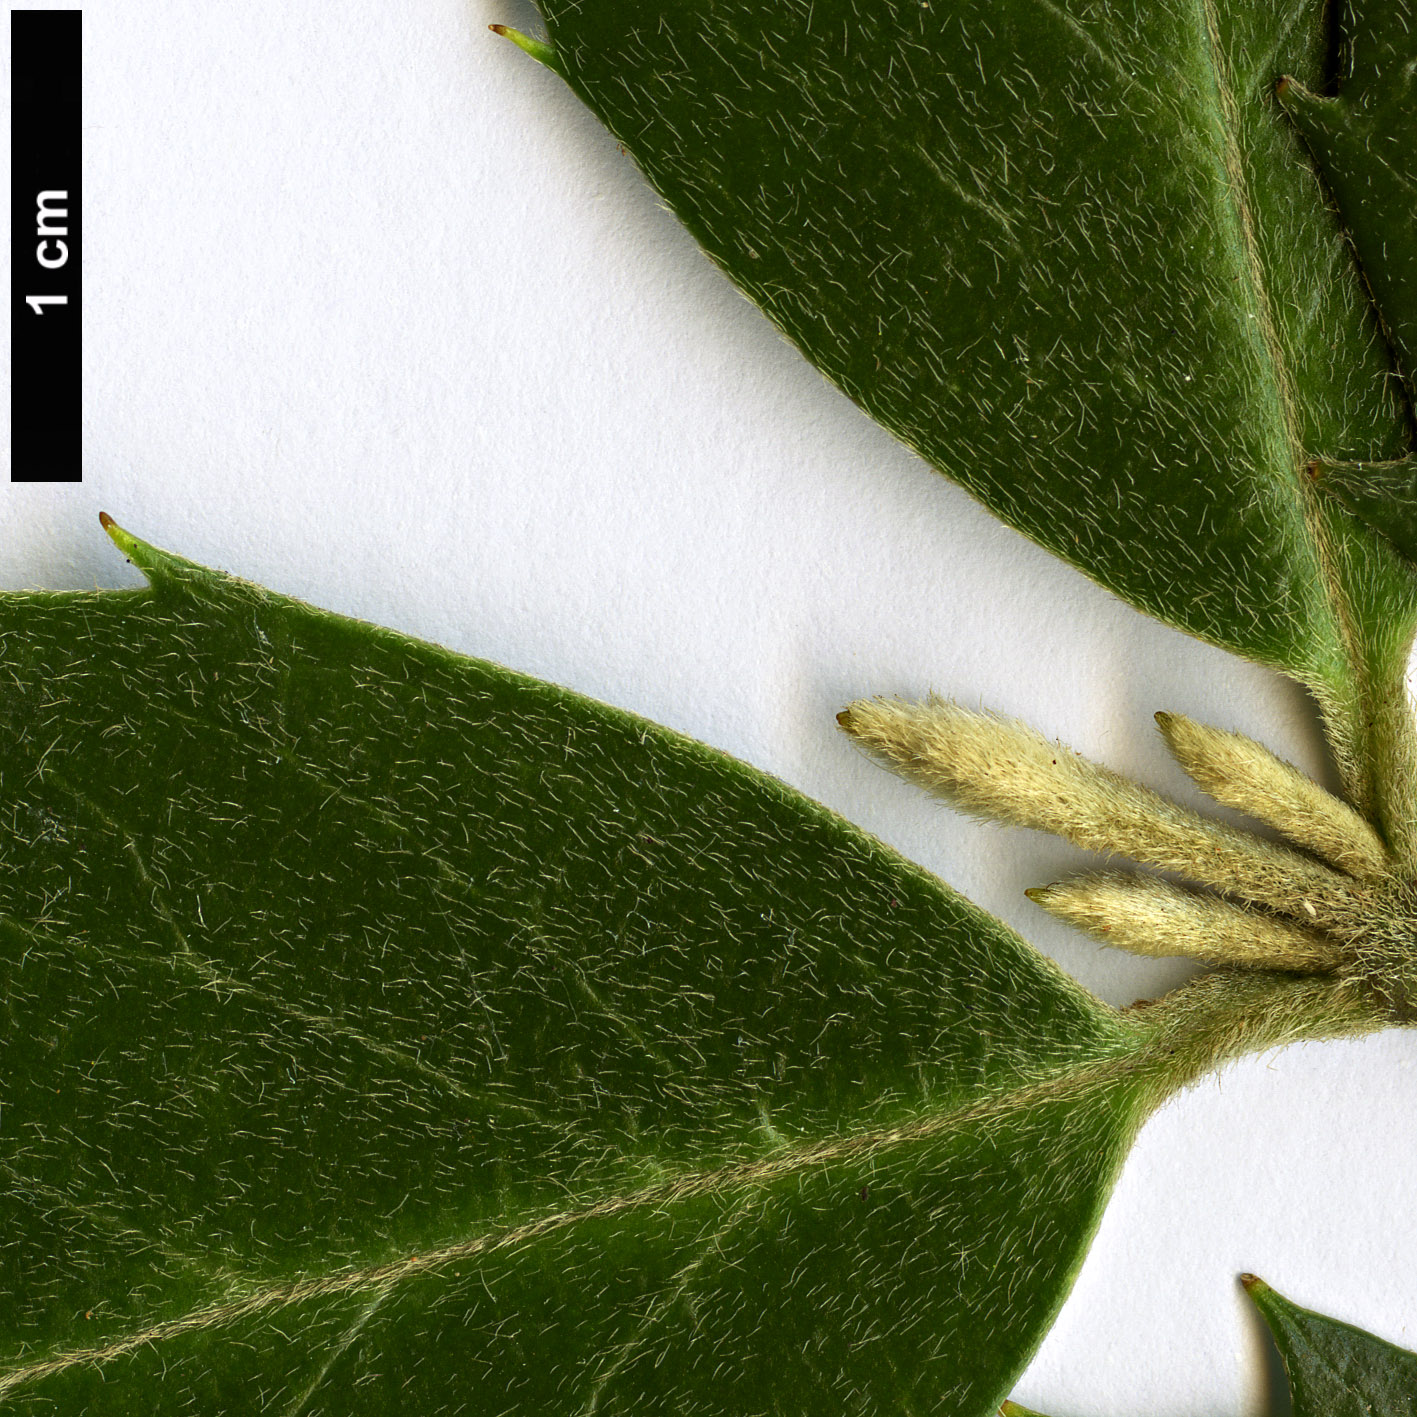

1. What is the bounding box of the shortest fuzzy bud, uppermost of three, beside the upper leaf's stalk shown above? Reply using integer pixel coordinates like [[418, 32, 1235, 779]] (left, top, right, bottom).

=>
[[1156, 713, 1391, 881]]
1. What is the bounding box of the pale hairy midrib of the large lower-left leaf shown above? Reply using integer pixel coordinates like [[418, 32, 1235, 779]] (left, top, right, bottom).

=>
[[0, 1039, 1158, 1401]]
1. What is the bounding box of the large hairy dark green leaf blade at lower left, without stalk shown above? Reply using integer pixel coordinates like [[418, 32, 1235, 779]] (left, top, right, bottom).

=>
[[0, 529, 1178, 1417]]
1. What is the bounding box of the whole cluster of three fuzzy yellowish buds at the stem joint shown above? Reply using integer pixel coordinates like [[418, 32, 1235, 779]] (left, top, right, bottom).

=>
[[837, 699, 1417, 1023]]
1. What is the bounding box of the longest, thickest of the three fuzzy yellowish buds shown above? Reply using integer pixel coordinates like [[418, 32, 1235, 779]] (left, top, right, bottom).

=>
[[837, 697, 1362, 932]]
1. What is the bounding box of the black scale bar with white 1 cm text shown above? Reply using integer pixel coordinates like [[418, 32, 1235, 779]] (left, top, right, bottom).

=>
[[10, 10, 84, 482]]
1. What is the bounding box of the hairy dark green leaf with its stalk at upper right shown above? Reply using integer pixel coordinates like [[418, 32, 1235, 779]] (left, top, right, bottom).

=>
[[518, 0, 1417, 833]]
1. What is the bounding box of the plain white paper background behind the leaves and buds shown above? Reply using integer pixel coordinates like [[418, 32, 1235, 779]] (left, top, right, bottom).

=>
[[0, 0, 1417, 1417]]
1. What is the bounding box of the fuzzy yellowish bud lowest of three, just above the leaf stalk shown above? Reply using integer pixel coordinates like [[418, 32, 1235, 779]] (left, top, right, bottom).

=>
[[1027, 871, 1345, 973]]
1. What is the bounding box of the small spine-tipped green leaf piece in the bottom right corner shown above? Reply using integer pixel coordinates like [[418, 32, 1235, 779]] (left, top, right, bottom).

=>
[[1244, 1274, 1417, 1417]]
